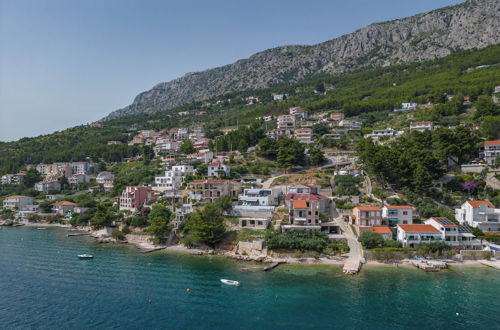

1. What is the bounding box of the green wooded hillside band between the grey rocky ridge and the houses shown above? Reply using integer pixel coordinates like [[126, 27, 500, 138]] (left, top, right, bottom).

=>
[[0, 45, 500, 174]]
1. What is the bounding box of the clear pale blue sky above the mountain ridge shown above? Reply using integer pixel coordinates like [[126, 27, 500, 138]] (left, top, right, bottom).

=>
[[0, 0, 462, 141]]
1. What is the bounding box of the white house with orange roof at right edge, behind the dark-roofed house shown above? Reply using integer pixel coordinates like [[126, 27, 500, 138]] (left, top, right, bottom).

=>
[[455, 200, 500, 232]]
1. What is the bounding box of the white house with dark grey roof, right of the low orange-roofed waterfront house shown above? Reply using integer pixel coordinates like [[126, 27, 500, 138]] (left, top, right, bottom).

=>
[[425, 217, 481, 250]]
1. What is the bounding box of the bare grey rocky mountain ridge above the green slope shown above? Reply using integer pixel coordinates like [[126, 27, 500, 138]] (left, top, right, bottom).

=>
[[104, 0, 500, 120]]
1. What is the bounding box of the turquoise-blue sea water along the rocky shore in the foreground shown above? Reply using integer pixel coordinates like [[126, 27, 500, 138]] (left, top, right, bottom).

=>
[[0, 228, 500, 329]]
